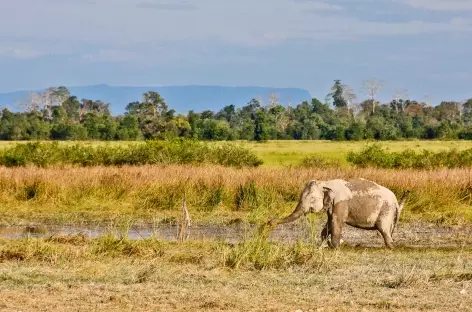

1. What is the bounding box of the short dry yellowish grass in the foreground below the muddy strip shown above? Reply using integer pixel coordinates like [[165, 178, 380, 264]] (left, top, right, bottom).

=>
[[0, 237, 472, 311]]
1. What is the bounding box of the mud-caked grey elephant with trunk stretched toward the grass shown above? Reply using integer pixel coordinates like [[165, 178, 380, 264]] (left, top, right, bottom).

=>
[[269, 178, 409, 248]]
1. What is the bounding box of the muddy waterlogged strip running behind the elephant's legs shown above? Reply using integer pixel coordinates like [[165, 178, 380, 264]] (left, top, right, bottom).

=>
[[0, 222, 472, 247]]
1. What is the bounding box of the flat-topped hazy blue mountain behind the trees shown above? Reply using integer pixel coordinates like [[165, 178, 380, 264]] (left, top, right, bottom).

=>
[[0, 85, 312, 115]]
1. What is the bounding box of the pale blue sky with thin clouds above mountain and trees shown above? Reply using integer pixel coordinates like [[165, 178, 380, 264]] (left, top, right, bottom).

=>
[[0, 0, 472, 103]]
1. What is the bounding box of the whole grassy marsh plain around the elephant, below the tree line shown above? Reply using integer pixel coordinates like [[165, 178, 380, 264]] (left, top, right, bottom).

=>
[[0, 141, 472, 311]]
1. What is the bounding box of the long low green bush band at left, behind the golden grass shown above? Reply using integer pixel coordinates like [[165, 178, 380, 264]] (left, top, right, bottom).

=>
[[0, 139, 262, 167]]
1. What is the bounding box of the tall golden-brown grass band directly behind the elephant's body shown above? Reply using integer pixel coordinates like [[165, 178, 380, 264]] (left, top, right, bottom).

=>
[[0, 165, 472, 224]]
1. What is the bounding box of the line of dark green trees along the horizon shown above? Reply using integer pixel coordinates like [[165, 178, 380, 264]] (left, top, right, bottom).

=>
[[0, 83, 472, 141]]
